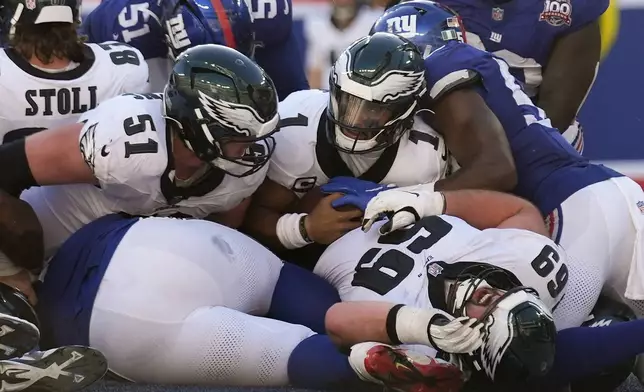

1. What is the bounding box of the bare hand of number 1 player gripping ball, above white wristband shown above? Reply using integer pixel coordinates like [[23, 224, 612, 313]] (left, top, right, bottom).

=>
[[304, 193, 362, 245]]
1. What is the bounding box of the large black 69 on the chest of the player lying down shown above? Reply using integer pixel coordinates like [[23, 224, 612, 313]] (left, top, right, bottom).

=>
[[351, 216, 452, 295]]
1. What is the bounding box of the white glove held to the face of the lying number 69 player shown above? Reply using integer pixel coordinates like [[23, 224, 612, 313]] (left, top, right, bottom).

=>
[[429, 317, 484, 354]]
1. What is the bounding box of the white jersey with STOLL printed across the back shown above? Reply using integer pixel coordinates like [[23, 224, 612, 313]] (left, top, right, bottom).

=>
[[0, 42, 149, 143]]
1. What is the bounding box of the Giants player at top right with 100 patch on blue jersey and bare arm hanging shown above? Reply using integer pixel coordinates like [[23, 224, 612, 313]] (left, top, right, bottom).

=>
[[390, 0, 609, 152]]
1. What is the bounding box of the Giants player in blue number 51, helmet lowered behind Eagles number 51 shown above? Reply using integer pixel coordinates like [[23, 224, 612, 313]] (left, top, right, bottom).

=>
[[83, 0, 308, 98]]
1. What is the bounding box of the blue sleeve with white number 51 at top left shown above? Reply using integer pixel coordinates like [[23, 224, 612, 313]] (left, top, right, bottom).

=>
[[82, 0, 168, 59]]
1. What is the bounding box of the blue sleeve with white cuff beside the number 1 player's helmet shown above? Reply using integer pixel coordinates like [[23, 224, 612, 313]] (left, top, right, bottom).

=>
[[425, 42, 485, 101]]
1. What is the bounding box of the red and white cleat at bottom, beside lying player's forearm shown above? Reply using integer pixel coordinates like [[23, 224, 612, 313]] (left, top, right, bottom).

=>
[[349, 343, 465, 392]]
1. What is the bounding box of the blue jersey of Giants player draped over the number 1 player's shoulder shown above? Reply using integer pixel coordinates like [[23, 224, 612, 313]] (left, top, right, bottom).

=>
[[425, 41, 622, 216]]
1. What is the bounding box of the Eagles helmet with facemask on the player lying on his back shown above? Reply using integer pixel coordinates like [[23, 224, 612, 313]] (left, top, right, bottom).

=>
[[446, 266, 556, 381]]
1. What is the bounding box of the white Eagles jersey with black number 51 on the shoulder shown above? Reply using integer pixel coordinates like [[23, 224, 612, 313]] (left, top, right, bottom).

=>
[[21, 94, 268, 255]]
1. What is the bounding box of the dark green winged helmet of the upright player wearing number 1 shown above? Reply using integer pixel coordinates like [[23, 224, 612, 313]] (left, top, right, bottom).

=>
[[327, 33, 427, 154]]
